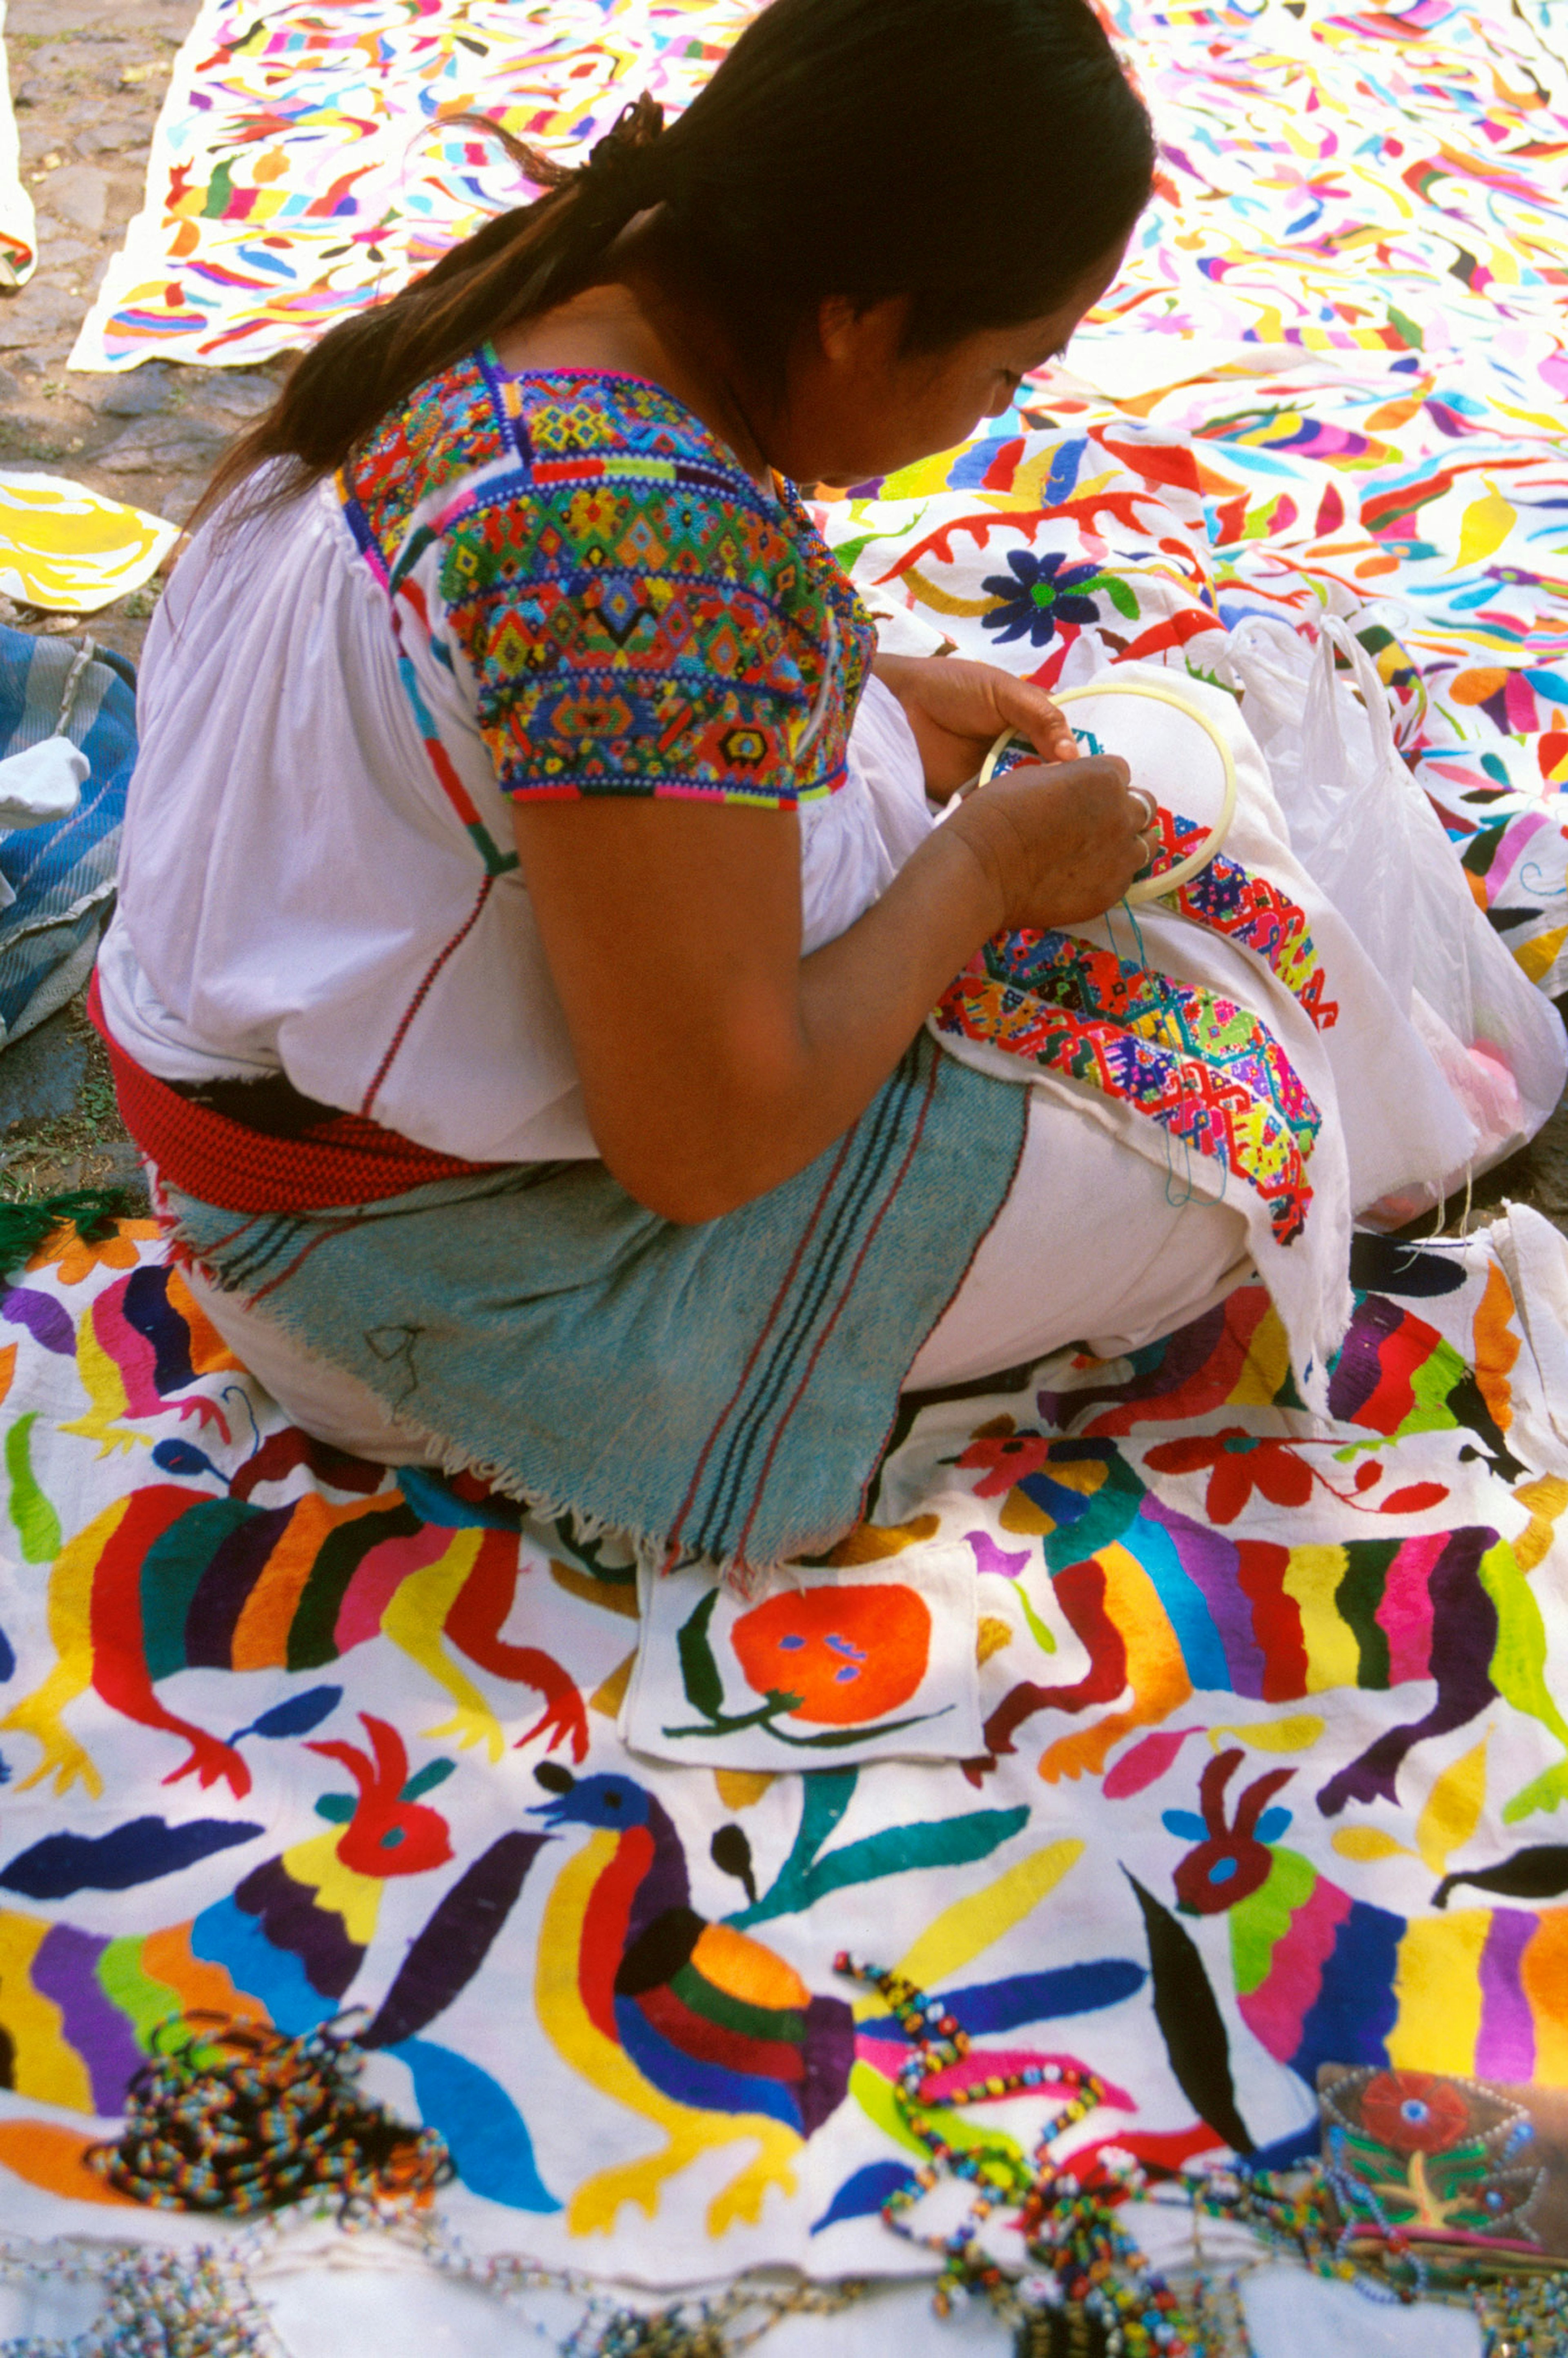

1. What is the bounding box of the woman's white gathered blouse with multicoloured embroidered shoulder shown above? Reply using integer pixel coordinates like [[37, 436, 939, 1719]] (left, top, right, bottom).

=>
[[104, 354, 891, 1163]]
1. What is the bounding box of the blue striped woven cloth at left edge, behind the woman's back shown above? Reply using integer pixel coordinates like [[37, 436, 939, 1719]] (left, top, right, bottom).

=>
[[0, 627, 137, 1045]]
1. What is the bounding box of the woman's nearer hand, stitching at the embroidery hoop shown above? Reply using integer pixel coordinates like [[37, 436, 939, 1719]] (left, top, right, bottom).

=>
[[946, 755, 1155, 932]]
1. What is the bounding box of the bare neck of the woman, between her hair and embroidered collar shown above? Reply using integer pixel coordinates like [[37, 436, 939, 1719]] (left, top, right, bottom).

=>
[[495, 217, 773, 493]]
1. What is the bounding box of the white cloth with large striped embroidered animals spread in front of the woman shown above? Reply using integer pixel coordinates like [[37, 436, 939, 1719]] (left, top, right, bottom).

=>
[[0, 1188, 1568, 2285]]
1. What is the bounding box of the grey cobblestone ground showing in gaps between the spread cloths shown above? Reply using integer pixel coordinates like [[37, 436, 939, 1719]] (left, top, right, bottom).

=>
[[0, 0, 1568, 1233]]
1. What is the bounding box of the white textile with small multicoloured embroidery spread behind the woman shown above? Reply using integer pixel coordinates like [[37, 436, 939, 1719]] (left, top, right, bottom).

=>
[[73, 0, 1568, 993]]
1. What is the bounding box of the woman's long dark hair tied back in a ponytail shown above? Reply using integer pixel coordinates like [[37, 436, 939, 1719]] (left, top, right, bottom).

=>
[[203, 0, 1155, 512]]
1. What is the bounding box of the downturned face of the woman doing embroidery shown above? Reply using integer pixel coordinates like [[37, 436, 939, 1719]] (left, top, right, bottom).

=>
[[768, 243, 1125, 484]]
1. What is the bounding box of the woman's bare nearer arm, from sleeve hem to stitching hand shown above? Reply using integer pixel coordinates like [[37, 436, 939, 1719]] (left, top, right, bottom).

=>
[[514, 757, 1148, 1221]]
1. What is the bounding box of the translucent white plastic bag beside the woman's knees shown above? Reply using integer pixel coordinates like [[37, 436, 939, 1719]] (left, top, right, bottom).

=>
[[1217, 613, 1568, 1198]]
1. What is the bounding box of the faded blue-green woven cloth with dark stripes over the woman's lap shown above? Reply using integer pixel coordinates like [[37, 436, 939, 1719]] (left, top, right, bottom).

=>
[[167, 1035, 1028, 1570]]
